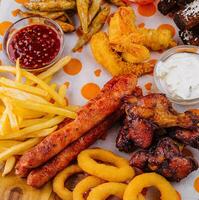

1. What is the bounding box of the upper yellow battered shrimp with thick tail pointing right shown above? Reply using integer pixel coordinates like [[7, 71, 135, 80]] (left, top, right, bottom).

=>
[[109, 7, 176, 51]]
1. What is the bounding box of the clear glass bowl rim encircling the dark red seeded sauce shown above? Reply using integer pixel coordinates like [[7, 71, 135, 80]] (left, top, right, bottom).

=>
[[3, 16, 64, 73]]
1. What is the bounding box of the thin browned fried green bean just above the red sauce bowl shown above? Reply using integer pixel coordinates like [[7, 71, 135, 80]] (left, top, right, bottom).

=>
[[19, 10, 65, 19]]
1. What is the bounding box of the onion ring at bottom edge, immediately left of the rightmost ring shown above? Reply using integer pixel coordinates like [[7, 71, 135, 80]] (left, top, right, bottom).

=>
[[87, 182, 127, 200]]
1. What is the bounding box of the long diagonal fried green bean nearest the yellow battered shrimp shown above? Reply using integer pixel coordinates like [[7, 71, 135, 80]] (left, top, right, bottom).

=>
[[73, 4, 110, 52]]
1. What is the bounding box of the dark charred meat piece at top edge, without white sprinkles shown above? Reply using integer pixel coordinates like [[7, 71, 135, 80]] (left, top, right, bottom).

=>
[[158, 0, 193, 15]]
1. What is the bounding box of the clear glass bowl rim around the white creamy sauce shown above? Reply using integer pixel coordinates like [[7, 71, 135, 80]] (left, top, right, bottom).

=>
[[154, 45, 199, 105]]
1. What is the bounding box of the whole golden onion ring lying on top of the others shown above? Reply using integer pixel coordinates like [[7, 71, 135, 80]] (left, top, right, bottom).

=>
[[77, 149, 135, 182]]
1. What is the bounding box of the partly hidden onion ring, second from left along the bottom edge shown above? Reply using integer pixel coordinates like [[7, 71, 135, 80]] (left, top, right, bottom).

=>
[[73, 176, 104, 200]]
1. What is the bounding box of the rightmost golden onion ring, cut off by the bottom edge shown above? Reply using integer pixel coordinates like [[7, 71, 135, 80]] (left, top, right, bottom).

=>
[[123, 173, 179, 200]]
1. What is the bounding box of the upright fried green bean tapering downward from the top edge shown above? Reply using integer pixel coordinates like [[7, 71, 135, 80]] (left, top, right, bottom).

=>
[[76, 0, 89, 33]]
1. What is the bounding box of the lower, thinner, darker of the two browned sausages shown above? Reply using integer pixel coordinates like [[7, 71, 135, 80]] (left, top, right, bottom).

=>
[[27, 111, 121, 188]]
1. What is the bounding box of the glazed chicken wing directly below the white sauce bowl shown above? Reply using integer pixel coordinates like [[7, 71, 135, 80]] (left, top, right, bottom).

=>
[[125, 94, 199, 128]]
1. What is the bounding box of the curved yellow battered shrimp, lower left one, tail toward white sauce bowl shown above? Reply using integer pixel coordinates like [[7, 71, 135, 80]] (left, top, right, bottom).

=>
[[90, 32, 154, 76]]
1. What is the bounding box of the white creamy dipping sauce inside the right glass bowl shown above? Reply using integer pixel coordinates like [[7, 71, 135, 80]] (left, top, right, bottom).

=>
[[157, 53, 199, 99]]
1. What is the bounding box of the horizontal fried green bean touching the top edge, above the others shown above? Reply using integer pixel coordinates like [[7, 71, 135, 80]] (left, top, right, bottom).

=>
[[24, 0, 75, 12]]
